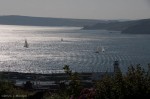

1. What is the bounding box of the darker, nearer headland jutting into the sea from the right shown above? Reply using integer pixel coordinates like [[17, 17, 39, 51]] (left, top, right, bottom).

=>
[[83, 19, 150, 34]]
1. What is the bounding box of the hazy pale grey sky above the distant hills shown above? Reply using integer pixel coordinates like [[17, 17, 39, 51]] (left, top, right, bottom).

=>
[[0, 0, 150, 19]]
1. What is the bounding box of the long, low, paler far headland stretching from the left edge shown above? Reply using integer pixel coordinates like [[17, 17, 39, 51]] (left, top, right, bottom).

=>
[[0, 15, 105, 27]]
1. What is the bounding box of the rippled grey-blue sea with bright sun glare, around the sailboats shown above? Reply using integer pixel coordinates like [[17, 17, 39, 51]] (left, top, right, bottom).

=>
[[0, 25, 150, 73]]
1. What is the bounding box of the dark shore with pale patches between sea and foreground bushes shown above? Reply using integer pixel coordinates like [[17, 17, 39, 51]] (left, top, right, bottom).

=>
[[0, 72, 113, 90]]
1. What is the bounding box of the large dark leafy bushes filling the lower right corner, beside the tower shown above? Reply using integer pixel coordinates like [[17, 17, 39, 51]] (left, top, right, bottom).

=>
[[96, 64, 150, 99]]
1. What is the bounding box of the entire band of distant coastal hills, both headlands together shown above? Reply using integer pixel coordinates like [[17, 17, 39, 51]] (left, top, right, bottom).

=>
[[0, 15, 150, 34]]
